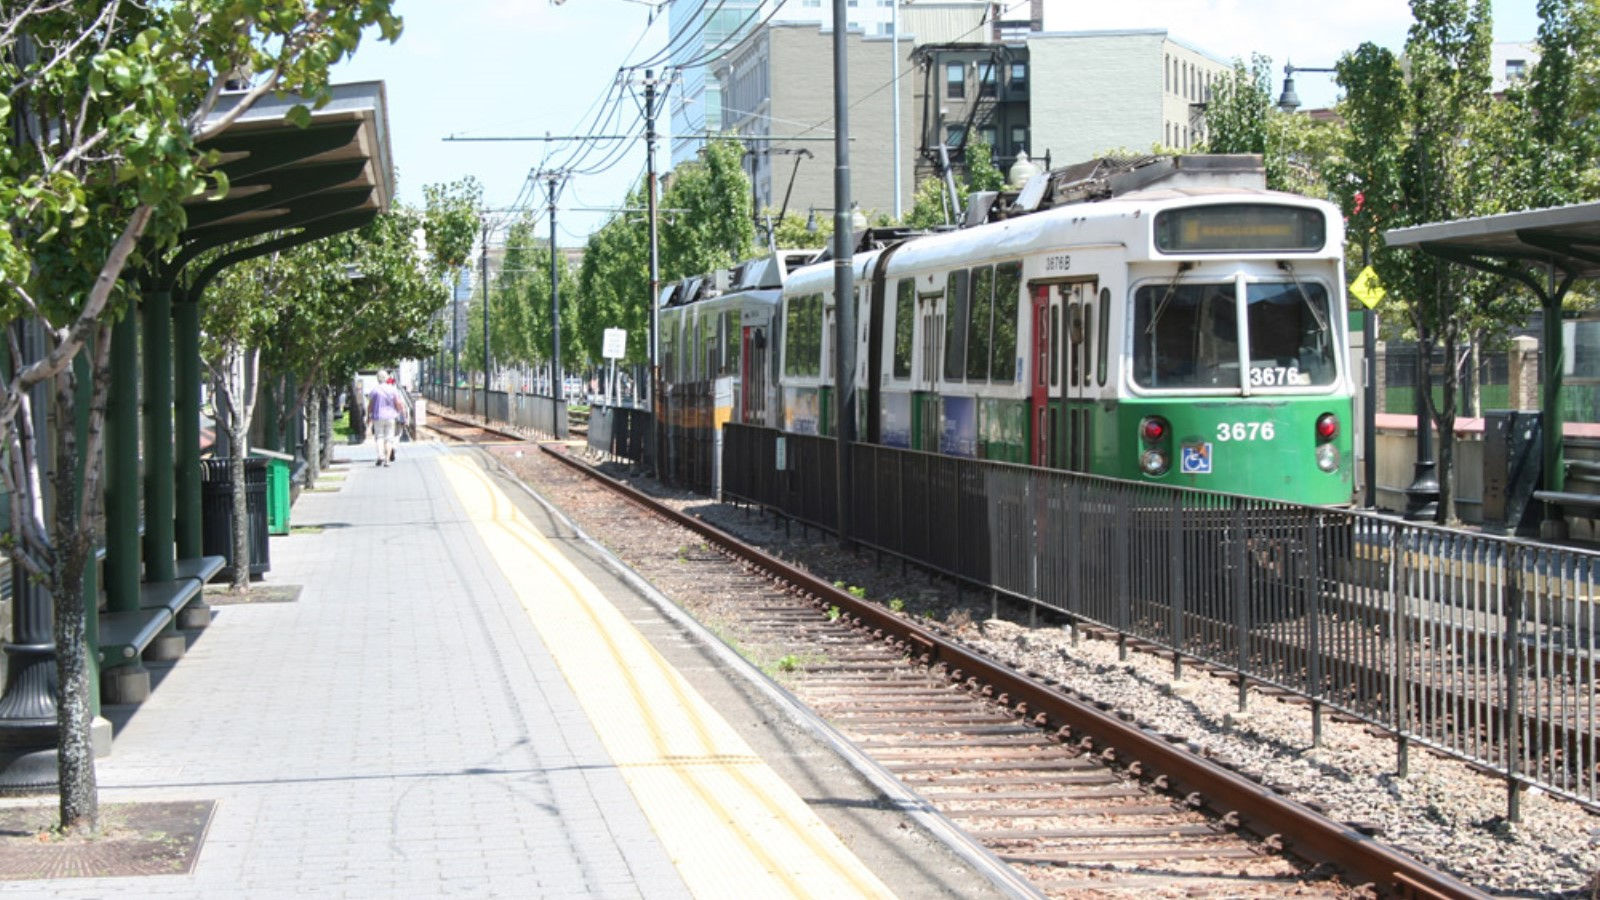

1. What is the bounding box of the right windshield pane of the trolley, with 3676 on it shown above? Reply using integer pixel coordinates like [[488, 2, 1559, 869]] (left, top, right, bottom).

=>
[[1245, 280, 1334, 388]]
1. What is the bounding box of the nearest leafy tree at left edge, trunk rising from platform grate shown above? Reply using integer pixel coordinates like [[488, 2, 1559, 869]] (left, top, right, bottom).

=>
[[0, 0, 400, 833]]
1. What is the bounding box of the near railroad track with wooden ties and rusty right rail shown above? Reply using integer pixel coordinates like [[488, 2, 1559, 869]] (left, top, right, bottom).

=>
[[534, 448, 1482, 897]]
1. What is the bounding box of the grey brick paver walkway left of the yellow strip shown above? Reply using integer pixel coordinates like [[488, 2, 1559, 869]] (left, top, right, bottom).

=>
[[18, 444, 685, 897]]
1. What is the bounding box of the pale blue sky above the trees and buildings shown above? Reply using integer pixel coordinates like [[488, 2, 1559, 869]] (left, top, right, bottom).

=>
[[334, 0, 1539, 247]]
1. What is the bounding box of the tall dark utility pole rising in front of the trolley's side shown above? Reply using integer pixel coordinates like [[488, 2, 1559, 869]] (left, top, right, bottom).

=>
[[834, 0, 857, 546]]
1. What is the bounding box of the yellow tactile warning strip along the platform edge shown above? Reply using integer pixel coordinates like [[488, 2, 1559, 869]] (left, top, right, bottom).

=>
[[440, 456, 893, 897]]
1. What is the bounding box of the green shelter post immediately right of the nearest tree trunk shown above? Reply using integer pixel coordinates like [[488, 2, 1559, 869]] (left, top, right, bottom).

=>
[[106, 307, 139, 612]]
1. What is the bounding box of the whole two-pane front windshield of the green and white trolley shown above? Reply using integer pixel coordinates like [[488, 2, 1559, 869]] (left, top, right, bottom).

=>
[[1133, 279, 1338, 391]]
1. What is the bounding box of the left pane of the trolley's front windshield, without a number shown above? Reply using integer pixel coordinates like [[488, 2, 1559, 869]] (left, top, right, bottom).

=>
[[1133, 282, 1240, 389]]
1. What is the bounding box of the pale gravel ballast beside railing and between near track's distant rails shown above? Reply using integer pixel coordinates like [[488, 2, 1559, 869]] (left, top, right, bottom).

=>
[[496, 438, 1600, 897]]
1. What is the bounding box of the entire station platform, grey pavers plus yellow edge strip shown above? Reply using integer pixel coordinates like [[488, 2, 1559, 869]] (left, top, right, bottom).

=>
[[21, 442, 1014, 898]]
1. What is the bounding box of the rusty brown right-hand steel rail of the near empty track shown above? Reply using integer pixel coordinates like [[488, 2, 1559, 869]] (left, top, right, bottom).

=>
[[539, 444, 1488, 898]]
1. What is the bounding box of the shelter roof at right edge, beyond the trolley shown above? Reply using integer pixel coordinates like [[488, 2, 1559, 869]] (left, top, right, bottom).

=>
[[1384, 203, 1600, 279]]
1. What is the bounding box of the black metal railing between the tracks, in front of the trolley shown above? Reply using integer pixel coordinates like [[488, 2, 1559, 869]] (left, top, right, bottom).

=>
[[723, 424, 1600, 820]]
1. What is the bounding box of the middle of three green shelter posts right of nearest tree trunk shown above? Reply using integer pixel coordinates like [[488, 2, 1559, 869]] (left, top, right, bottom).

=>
[[139, 291, 178, 581]]
